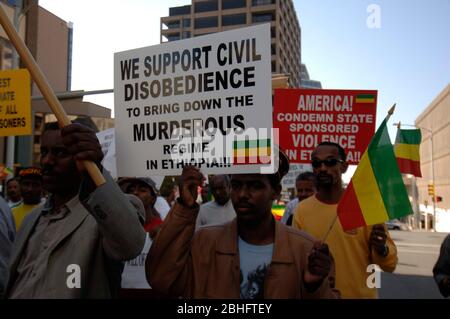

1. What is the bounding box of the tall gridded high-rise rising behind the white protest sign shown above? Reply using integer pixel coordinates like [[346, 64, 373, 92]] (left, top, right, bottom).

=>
[[160, 0, 301, 87]]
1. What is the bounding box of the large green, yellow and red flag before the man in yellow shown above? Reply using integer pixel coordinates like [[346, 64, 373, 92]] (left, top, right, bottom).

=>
[[337, 111, 412, 230]]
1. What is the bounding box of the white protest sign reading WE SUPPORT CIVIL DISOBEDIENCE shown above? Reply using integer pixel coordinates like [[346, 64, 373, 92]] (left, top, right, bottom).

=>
[[114, 24, 278, 176]]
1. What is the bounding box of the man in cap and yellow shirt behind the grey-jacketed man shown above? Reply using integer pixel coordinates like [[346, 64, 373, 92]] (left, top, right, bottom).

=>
[[12, 167, 42, 230]]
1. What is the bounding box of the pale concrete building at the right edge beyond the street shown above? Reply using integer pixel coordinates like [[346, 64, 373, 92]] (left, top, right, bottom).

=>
[[415, 84, 450, 210]]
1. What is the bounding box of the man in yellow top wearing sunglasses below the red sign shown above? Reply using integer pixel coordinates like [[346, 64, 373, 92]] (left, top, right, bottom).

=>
[[293, 142, 398, 298]]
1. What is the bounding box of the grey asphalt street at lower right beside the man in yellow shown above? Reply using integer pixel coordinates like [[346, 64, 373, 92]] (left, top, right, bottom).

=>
[[379, 230, 447, 299]]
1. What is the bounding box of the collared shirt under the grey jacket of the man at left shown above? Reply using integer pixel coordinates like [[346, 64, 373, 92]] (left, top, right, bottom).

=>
[[9, 195, 78, 298]]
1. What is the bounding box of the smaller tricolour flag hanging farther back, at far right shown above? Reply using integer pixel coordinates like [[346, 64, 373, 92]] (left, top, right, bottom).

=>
[[394, 129, 422, 177]]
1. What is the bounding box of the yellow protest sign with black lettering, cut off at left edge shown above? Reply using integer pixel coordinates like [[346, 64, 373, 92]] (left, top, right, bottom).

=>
[[0, 69, 32, 136]]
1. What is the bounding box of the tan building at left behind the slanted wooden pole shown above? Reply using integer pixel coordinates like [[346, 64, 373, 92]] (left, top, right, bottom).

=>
[[0, 0, 113, 170]]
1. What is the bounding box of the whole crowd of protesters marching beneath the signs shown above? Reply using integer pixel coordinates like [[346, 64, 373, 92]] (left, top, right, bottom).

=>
[[0, 119, 450, 299]]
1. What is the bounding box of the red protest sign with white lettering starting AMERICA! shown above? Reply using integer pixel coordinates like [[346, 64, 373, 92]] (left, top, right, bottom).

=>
[[273, 89, 377, 164]]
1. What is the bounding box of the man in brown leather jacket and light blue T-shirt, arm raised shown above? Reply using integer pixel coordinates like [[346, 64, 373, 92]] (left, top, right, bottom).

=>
[[146, 151, 337, 299]]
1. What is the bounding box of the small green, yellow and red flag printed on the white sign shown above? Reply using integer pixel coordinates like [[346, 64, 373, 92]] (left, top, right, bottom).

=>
[[233, 139, 271, 165]]
